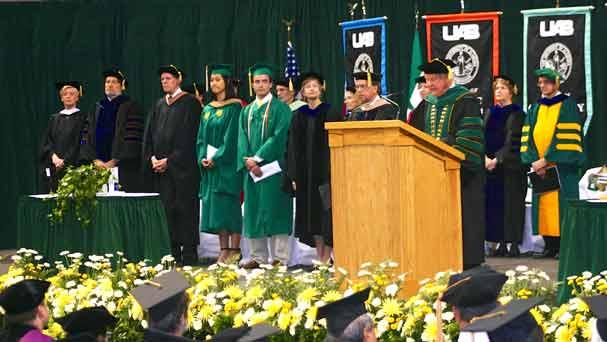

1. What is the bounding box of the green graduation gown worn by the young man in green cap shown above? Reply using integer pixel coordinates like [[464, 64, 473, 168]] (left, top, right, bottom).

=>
[[237, 97, 293, 239]]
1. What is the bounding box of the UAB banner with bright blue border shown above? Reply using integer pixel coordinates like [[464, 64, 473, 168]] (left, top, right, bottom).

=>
[[340, 17, 388, 94]]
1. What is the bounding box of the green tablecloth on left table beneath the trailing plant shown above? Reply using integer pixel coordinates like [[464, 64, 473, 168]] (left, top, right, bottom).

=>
[[17, 196, 171, 263]]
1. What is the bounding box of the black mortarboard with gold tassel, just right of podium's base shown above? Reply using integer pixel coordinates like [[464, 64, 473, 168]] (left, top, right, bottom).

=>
[[441, 267, 508, 308]]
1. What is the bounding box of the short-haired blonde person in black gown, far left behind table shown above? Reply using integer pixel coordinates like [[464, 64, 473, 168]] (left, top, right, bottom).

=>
[[39, 81, 86, 193]]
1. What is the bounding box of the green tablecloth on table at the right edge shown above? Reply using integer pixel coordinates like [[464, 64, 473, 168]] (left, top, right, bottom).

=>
[[558, 200, 607, 303]]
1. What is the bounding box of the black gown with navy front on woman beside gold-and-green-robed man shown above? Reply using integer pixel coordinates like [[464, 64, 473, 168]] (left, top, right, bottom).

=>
[[485, 104, 527, 243]]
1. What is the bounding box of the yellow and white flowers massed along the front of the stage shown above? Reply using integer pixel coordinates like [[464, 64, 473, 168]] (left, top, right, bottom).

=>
[[0, 249, 607, 342]]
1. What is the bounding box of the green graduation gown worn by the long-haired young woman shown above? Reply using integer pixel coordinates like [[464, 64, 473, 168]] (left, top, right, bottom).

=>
[[196, 99, 242, 234]]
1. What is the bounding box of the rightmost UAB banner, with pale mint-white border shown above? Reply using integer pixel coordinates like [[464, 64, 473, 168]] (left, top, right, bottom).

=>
[[521, 6, 593, 134]]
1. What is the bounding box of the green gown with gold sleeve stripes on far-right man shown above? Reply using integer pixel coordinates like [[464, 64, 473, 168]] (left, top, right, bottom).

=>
[[521, 94, 585, 236]]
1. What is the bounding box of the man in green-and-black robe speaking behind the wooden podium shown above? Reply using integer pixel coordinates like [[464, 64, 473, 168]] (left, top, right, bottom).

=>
[[410, 58, 485, 269]]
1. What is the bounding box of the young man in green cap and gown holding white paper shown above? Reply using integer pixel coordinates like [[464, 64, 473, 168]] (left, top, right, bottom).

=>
[[237, 64, 293, 269]]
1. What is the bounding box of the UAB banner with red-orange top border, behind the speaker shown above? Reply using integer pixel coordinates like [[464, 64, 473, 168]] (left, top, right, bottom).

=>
[[426, 12, 501, 107]]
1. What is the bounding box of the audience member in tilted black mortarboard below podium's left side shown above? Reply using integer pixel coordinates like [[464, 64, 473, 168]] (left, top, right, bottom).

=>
[[316, 288, 377, 342]]
